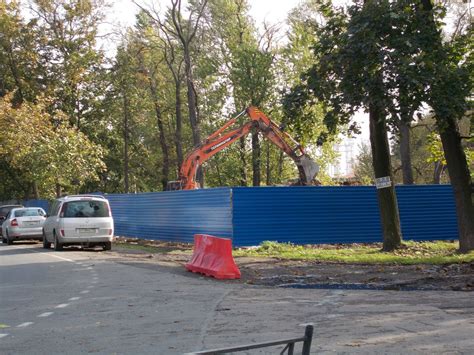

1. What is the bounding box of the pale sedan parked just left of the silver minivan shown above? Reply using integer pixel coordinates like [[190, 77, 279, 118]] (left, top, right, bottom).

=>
[[2, 207, 46, 244]]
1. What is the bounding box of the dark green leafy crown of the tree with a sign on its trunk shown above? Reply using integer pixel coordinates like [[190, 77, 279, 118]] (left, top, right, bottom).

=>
[[285, 1, 468, 139]]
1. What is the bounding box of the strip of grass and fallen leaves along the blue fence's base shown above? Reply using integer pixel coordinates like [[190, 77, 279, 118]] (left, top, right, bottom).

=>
[[114, 238, 474, 265]]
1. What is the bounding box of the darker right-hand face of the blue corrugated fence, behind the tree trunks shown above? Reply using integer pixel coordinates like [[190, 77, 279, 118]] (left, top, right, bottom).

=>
[[233, 185, 458, 246]]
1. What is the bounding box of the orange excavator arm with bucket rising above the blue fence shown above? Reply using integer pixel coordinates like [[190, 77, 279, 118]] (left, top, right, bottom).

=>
[[167, 107, 319, 190]]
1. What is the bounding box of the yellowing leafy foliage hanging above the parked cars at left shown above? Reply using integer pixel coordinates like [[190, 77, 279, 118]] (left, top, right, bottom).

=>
[[0, 95, 105, 197]]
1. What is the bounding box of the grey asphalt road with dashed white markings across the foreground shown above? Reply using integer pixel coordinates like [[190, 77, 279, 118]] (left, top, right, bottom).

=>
[[0, 243, 474, 354]]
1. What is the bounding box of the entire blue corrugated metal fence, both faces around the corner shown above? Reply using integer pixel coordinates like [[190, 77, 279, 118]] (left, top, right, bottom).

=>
[[20, 185, 458, 246]]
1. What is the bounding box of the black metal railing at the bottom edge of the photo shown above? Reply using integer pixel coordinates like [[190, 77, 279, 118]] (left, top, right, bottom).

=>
[[185, 325, 313, 355]]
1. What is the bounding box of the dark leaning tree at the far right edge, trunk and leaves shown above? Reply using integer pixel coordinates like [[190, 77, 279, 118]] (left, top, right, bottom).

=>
[[416, 0, 474, 252]]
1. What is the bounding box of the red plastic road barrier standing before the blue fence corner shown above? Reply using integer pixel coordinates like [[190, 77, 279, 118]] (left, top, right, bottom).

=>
[[185, 234, 240, 279]]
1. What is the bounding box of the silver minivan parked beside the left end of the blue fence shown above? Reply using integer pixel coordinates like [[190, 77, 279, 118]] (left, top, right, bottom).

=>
[[43, 195, 114, 250]]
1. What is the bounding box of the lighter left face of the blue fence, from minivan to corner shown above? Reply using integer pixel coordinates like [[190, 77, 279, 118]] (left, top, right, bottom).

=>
[[106, 188, 232, 243]]
